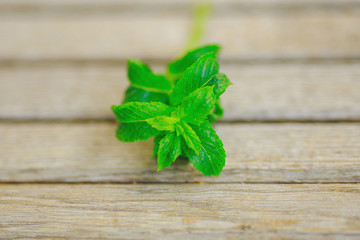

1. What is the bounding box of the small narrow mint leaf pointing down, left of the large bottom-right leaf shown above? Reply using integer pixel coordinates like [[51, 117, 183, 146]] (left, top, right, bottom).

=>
[[158, 132, 181, 171]]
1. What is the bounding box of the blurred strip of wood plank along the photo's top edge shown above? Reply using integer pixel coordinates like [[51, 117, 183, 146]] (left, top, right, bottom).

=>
[[0, 0, 360, 19]]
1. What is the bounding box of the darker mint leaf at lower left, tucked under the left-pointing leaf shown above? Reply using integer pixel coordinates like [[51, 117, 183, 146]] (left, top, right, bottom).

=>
[[116, 122, 158, 142]]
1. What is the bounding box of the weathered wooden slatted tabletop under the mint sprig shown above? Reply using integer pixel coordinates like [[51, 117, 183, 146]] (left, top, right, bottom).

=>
[[0, 0, 360, 240]]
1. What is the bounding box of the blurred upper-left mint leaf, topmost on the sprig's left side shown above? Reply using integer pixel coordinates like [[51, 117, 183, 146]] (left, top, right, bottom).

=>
[[128, 60, 172, 93]]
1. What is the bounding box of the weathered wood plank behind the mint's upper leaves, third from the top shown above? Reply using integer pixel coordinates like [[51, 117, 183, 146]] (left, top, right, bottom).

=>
[[0, 64, 360, 121]]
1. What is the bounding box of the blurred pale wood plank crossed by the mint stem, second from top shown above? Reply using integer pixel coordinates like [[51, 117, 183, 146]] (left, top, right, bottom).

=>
[[0, 9, 360, 60]]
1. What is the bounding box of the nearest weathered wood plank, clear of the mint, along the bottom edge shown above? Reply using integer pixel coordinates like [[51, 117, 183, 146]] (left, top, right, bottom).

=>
[[0, 184, 360, 240]]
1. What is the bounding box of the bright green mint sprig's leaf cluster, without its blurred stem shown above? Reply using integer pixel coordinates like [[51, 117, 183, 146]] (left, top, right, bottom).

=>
[[112, 45, 231, 176]]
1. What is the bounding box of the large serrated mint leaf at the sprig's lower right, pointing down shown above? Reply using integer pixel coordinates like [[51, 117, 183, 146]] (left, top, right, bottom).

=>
[[185, 122, 226, 176]]
